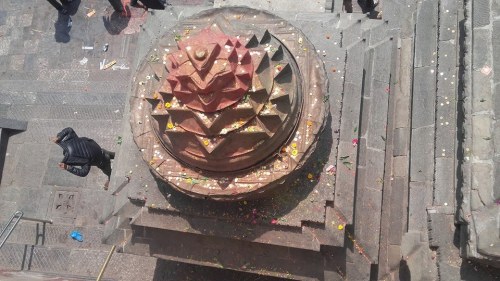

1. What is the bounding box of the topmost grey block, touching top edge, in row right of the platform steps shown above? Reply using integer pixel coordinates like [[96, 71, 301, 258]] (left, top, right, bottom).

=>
[[414, 0, 438, 67]]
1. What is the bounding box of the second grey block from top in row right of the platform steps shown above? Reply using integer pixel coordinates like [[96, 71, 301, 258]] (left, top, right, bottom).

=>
[[412, 66, 436, 129]]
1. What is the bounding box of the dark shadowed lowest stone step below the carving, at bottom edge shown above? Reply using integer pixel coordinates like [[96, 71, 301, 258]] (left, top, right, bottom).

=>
[[130, 226, 328, 280]]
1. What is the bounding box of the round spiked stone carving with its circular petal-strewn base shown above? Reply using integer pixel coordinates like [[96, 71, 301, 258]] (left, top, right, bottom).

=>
[[131, 8, 328, 200]]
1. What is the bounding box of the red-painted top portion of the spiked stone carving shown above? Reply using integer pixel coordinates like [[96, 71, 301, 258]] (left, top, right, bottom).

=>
[[164, 28, 254, 113]]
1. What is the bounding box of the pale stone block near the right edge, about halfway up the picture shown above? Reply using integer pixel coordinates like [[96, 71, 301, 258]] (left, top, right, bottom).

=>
[[472, 114, 493, 160]]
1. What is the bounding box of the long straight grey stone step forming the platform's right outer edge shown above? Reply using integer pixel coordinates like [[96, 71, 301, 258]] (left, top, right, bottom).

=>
[[354, 38, 393, 263]]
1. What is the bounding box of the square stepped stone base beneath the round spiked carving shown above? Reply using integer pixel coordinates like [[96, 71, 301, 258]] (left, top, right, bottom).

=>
[[100, 4, 403, 280]]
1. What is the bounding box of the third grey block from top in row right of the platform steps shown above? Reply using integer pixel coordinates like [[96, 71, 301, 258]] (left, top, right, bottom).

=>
[[410, 126, 434, 182]]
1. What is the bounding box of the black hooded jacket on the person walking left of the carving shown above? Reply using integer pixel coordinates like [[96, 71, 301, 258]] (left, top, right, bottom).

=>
[[57, 127, 104, 177]]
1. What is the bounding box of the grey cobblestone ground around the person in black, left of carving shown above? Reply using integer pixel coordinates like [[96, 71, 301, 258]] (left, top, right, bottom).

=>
[[0, 0, 204, 280]]
